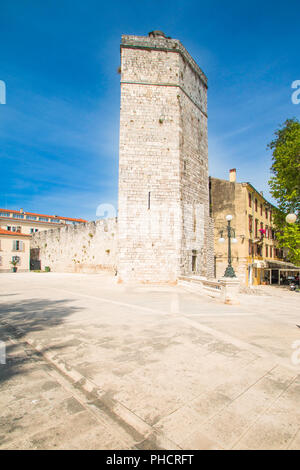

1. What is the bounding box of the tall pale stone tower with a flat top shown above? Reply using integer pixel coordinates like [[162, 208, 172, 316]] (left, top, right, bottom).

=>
[[118, 31, 213, 283]]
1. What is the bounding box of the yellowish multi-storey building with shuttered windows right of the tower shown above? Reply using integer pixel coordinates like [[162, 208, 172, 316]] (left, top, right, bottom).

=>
[[210, 169, 289, 285]]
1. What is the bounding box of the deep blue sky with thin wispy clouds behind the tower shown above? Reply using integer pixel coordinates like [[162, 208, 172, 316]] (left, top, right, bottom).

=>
[[0, 0, 300, 220]]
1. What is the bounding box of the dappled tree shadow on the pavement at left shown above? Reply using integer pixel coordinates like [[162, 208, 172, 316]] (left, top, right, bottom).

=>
[[0, 299, 81, 389]]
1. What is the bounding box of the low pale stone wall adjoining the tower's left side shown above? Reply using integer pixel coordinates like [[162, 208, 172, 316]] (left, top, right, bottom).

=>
[[31, 218, 118, 273]]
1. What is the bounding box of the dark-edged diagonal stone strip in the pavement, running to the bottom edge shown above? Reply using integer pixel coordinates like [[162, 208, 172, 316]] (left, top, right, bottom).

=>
[[1, 321, 181, 450]]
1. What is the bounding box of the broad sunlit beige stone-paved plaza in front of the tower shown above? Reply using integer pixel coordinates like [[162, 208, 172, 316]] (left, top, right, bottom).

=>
[[0, 273, 300, 450]]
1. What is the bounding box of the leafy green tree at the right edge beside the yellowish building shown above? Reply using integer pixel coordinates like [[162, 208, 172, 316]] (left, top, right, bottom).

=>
[[268, 118, 300, 265]]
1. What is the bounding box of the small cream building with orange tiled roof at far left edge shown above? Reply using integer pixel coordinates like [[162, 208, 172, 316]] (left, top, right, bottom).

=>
[[0, 228, 31, 273]]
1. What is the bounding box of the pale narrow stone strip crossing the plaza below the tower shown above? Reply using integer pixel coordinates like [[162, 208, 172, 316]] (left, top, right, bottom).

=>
[[44, 287, 295, 371]]
